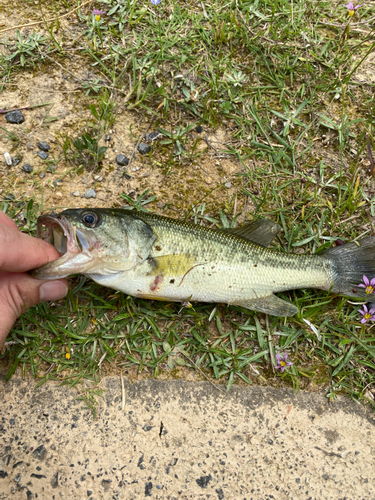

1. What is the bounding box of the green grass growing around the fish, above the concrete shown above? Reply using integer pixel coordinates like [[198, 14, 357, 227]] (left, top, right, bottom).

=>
[[0, 0, 375, 405]]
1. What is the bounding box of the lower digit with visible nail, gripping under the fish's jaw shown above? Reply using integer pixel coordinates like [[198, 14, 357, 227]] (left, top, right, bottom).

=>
[[0, 272, 68, 347]]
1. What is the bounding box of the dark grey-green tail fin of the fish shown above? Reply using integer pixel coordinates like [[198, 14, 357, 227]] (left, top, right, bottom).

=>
[[320, 237, 375, 298]]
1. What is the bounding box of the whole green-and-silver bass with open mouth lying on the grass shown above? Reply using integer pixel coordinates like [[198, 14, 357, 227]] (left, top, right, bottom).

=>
[[31, 208, 375, 317]]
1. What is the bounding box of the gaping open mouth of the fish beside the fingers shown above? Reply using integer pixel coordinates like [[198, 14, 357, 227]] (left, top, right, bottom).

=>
[[30, 215, 93, 279]]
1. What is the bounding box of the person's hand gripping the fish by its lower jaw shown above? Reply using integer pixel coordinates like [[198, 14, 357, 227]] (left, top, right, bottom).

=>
[[0, 211, 68, 348]]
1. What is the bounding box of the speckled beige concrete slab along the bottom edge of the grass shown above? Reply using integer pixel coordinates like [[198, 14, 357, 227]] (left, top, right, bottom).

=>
[[0, 377, 375, 500]]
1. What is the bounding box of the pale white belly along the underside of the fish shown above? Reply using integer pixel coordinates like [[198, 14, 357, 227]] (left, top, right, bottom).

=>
[[89, 261, 327, 304]]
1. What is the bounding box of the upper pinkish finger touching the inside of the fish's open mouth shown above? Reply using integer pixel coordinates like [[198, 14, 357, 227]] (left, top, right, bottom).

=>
[[0, 224, 60, 272]]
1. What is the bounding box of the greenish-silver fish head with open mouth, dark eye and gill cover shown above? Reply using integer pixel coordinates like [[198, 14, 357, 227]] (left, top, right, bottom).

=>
[[31, 208, 156, 279]]
